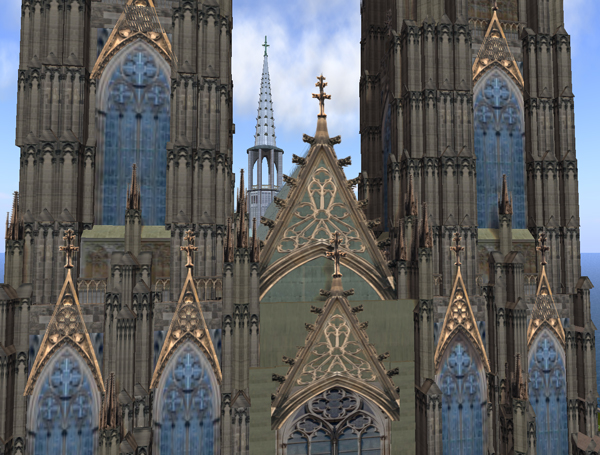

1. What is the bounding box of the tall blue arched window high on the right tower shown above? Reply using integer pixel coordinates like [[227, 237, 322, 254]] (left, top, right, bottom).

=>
[[473, 68, 527, 229]]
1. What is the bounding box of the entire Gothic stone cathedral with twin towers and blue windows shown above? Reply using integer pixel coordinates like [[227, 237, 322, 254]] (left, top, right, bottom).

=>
[[0, 0, 600, 455]]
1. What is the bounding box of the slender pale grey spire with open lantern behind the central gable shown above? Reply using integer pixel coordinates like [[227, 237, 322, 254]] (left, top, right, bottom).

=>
[[248, 36, 283, 224]]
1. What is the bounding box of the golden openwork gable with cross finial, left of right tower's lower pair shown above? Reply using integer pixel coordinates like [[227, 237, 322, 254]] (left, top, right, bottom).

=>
[[434, 232, 491, 373]]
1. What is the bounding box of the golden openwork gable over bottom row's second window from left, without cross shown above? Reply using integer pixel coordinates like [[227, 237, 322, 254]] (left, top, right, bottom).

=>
[[150, 267, 223, 389]]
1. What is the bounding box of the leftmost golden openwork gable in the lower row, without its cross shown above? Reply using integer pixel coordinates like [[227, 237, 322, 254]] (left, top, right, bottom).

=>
[[25, 268, 104, 395]]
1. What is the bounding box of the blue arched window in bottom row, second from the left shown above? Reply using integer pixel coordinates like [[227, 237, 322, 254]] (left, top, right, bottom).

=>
[[154, 341, 221, 455]]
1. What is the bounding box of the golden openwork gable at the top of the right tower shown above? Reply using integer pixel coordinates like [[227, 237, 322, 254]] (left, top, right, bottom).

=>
[[473, 9, 525, 88]]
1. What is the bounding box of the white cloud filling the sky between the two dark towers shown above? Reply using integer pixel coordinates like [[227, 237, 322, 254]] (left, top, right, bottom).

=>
[[233, 0, 360, 142]]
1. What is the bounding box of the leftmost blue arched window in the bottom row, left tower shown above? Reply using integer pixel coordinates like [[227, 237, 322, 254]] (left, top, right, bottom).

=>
[[28, 346, 100, 455]]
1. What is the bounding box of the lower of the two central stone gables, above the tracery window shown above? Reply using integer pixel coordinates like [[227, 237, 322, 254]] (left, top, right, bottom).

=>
[[271, 284, 399, 428]]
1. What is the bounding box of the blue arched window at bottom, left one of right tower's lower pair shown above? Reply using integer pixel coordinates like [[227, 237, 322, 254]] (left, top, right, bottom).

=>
[[436, 335, 487, 455]]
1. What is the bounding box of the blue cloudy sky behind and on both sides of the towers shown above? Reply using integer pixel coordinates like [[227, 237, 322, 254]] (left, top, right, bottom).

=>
[[0, 0, 600, 253]]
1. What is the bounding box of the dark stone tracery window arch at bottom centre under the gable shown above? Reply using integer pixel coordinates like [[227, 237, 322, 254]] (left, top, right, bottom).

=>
[[278, 387, 389, 455]]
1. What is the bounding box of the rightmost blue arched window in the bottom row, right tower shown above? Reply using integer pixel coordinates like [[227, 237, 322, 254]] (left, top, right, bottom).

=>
[[528, 329, 569, 455]]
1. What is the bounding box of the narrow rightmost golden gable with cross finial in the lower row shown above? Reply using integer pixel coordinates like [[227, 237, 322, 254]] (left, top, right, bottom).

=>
[[527, 232, 565, 346]]
